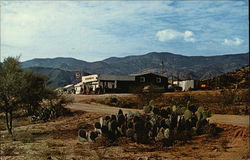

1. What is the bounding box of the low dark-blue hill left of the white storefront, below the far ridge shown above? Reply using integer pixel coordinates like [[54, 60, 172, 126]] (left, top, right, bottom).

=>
[[27, 67, 88, 88]]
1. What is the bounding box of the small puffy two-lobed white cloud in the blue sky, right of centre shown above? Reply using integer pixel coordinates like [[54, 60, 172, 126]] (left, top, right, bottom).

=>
[[156, 29, 196, 42]]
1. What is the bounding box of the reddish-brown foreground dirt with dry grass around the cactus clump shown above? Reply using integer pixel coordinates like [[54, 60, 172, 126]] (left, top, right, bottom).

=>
[[0, 108, 250, 160]]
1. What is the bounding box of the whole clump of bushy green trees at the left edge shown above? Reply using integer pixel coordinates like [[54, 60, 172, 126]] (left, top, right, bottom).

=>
[[0, 57, 53, 134]]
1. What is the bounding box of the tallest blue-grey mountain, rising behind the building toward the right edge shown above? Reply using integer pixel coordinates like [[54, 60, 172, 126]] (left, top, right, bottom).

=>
[[104, 52, 249, 79]]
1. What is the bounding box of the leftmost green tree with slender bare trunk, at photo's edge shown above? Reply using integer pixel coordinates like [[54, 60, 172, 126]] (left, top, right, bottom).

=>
[[0, 57, 24, 134]]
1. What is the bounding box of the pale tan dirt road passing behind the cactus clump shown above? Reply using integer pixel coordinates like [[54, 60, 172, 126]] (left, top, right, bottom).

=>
[[68, 103, 249, 127]]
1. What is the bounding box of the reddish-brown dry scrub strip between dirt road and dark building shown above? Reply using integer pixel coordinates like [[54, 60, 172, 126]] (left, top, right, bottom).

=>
[[76, 89, 249, 114]]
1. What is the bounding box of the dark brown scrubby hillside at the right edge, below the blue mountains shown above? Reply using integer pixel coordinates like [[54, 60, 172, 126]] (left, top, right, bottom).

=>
[[203, 66, 250, 88]]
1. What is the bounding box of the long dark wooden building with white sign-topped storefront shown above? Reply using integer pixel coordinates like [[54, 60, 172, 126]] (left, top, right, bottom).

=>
[[72, 73, 168, 94]]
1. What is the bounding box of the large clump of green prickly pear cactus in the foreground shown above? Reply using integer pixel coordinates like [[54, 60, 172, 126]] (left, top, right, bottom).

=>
[[78, 101, 211, 145]]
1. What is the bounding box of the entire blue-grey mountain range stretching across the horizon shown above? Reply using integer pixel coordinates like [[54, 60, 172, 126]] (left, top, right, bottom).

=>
[[22, 52, 249, 87]]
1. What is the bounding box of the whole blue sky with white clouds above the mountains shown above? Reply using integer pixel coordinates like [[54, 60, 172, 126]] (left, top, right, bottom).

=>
[[0, 0, 249, 62]]
